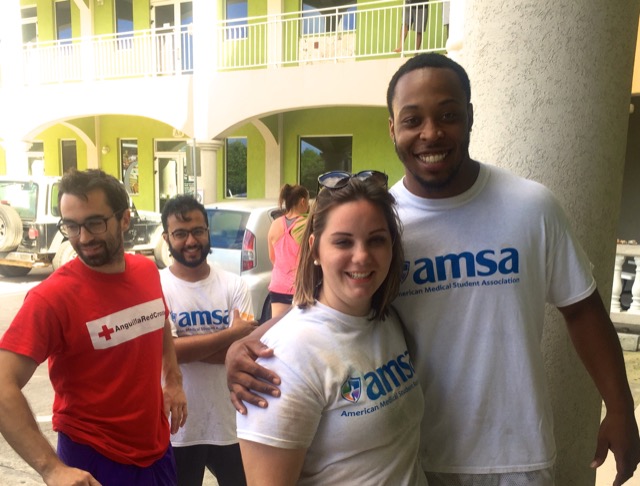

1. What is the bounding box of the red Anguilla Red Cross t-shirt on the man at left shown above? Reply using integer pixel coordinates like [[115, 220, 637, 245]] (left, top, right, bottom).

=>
[[0, 255, 169, 467]]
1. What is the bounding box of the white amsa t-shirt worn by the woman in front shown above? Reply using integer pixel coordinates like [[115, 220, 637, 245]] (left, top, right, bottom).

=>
[[237, 303, 426, 486]]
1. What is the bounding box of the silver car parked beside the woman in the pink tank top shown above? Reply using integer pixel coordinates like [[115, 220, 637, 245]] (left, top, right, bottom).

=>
[[205, 200, 282, 322]]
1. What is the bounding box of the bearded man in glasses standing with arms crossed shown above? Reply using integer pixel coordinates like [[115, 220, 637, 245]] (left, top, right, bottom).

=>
[[160, 195, 257, 486]]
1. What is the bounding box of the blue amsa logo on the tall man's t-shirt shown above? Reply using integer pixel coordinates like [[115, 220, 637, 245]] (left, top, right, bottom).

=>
[[402, 248, 520, 285]]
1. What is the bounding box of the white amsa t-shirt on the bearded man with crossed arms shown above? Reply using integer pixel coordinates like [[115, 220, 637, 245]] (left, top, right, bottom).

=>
[[160, 266, 253, 447]]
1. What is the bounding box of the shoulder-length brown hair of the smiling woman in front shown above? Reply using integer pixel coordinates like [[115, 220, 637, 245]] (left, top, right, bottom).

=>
[[294, 177, 404, 320]]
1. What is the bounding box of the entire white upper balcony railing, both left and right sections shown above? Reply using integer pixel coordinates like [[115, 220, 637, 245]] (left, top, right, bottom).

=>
[[15, 0, 449, 85]]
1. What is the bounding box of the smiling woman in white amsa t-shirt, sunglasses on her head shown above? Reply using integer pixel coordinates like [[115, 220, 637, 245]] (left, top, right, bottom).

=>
[[237, 171, 426, 486]]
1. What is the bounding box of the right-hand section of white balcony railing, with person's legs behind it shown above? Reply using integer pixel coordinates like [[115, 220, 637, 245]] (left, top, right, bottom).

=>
[[217, 0, 449, 70]]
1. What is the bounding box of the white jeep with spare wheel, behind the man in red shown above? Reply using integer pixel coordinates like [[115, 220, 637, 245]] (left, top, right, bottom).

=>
[[0, 176, 162, 277]]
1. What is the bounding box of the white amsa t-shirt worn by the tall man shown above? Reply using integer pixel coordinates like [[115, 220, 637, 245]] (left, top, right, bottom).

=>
[[392, 165, 596, 474]]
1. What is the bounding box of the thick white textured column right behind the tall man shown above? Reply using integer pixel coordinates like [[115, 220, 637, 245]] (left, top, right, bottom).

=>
[[463, 0, 639, 486]]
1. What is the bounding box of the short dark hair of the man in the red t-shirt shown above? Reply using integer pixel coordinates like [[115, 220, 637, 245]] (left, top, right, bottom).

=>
[[58, 169, 129, 221]]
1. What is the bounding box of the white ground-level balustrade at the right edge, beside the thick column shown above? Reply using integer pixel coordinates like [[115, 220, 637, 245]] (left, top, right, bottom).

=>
[[611, 244, 640, 331]]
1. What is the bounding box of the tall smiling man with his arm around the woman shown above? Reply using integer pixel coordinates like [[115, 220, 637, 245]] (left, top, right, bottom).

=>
[[227, 54, 640, 486]]
